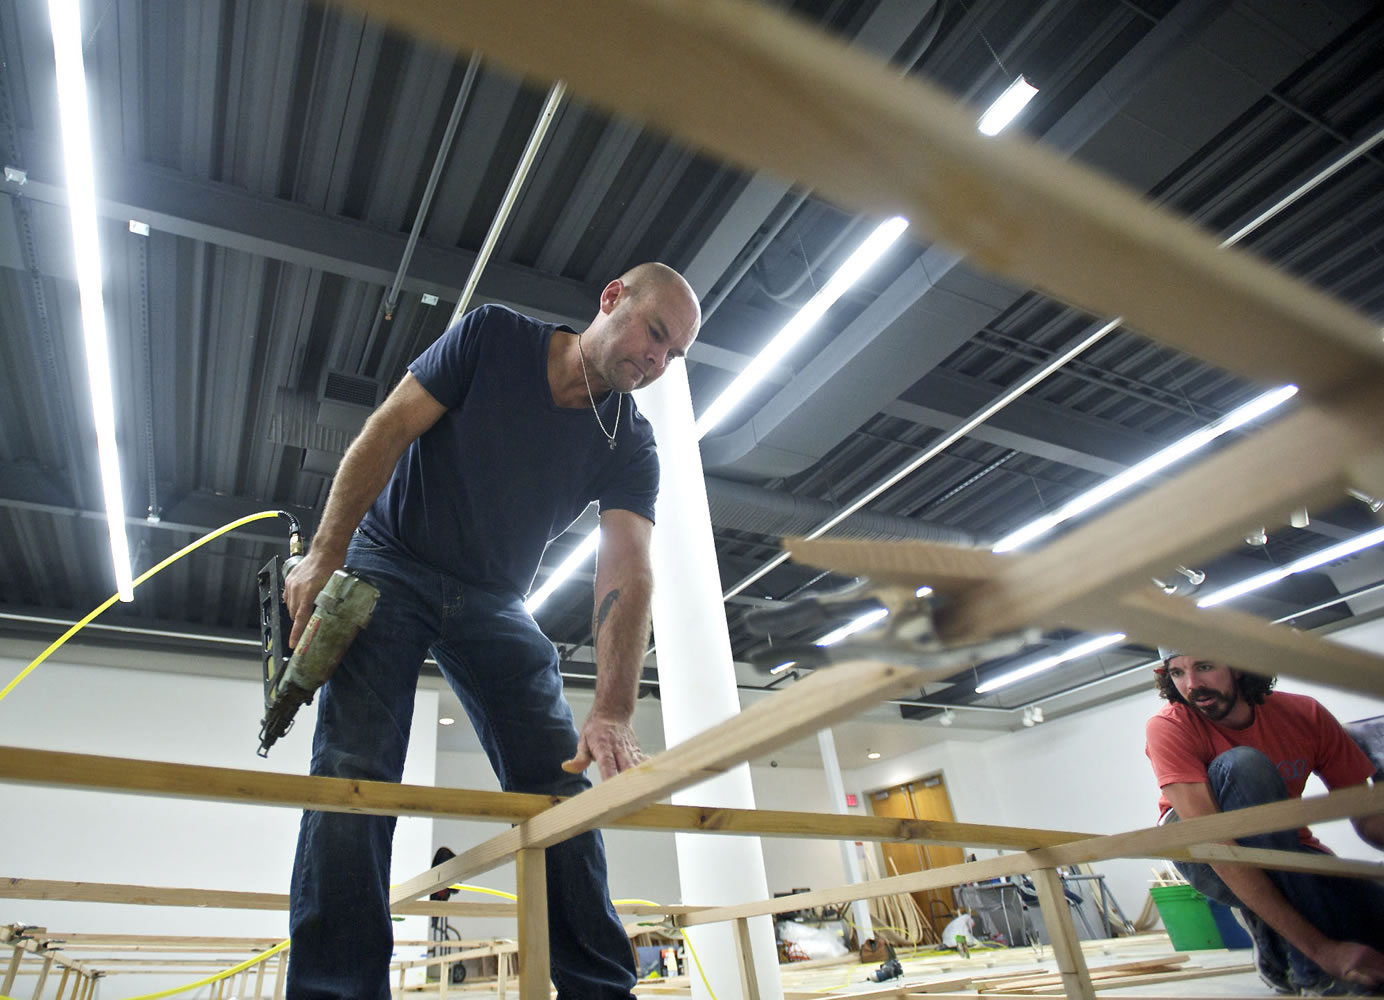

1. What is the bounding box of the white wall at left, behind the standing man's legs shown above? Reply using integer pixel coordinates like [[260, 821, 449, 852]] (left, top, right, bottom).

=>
[[0, 651, 437, 997]]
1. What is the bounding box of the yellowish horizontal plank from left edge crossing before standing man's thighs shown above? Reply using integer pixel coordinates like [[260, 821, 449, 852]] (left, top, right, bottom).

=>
[[0, 747, 1091, 849]]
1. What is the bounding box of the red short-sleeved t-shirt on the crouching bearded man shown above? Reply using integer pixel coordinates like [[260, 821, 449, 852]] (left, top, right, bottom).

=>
[[1145, 692, 1374, 851]]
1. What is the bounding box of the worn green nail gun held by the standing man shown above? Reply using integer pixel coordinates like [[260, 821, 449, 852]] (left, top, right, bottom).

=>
[[257, 512, 379, 757]]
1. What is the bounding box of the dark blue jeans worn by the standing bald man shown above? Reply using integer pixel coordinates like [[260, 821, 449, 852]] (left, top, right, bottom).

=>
[[288, 531, 634, 1000]]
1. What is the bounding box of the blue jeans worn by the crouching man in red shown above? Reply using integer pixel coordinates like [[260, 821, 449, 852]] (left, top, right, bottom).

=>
[[1178, 747, 1384, 988]]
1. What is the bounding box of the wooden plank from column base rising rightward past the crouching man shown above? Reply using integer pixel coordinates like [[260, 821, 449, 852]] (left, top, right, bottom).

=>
[[678, 786, 1384, 927]]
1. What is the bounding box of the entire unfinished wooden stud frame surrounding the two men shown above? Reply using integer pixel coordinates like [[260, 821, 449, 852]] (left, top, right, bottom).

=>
[[8, 0, 1384, 997]]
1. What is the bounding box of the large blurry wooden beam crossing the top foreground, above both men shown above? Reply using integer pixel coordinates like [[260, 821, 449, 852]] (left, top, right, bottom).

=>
[[343, 0, 1384, 394]]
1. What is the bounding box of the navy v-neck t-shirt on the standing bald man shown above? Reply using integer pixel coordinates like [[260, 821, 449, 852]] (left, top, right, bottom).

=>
[[361, 306, 659, 593]]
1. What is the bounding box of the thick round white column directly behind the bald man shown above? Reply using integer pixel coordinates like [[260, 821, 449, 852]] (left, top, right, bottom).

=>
[[635, 365, 783, 1000]]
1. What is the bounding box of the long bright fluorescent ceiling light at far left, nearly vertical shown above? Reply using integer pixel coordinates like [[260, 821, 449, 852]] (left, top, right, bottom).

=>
[[48, 0, 134, 602]]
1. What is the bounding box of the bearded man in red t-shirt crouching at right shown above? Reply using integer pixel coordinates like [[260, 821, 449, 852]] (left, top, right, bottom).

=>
[[1145, 650, 1384, 996]]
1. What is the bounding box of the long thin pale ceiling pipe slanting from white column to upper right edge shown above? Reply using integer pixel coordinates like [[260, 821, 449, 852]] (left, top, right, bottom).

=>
[[722, 119, 1384, 599]]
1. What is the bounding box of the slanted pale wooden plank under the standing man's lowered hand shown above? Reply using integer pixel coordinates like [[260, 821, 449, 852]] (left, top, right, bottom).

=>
[[389, 661, 943, 902]]
